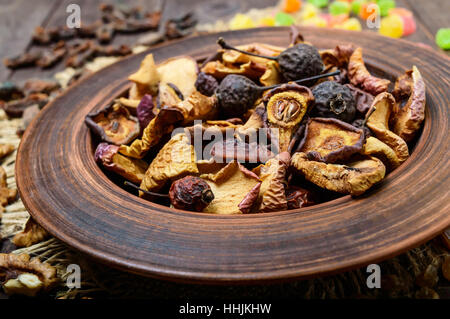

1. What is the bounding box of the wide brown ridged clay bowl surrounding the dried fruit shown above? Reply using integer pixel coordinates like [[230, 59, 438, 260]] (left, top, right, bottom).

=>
[[16, 28, 450, 283]]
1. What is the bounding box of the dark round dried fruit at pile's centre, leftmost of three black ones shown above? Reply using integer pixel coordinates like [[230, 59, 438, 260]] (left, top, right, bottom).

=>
[[216, 74, 260, 117]]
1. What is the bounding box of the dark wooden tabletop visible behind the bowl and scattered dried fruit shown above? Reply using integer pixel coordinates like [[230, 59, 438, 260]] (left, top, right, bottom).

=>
[[0, 0, 450, 81]]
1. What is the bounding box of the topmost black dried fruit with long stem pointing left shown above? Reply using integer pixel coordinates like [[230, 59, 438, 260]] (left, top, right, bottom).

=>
[[217, 38, 323, 85]]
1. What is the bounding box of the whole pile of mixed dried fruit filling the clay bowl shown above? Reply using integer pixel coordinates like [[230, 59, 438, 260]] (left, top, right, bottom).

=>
[[86, 30, 426, 214]]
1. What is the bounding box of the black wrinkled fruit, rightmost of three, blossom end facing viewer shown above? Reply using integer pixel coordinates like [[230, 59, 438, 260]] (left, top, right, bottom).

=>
[[311, 81, 356, 123]]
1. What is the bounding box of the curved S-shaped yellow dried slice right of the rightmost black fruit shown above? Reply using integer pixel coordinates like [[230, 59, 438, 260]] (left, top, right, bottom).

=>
[[367, 92, 409, 163]]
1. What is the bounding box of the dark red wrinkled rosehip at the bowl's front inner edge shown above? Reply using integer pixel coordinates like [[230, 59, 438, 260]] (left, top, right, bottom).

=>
[[169, 176, 214, 212]]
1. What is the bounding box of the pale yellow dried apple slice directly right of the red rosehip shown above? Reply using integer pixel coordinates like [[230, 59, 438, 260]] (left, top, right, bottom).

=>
[[200, 162, 260, 215]]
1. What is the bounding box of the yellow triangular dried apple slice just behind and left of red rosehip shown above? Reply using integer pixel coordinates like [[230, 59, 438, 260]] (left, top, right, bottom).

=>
[[141, 133, 198, 194]]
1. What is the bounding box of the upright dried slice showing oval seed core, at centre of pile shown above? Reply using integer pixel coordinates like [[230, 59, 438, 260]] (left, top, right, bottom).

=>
[[264, 83, 314, 152]]
